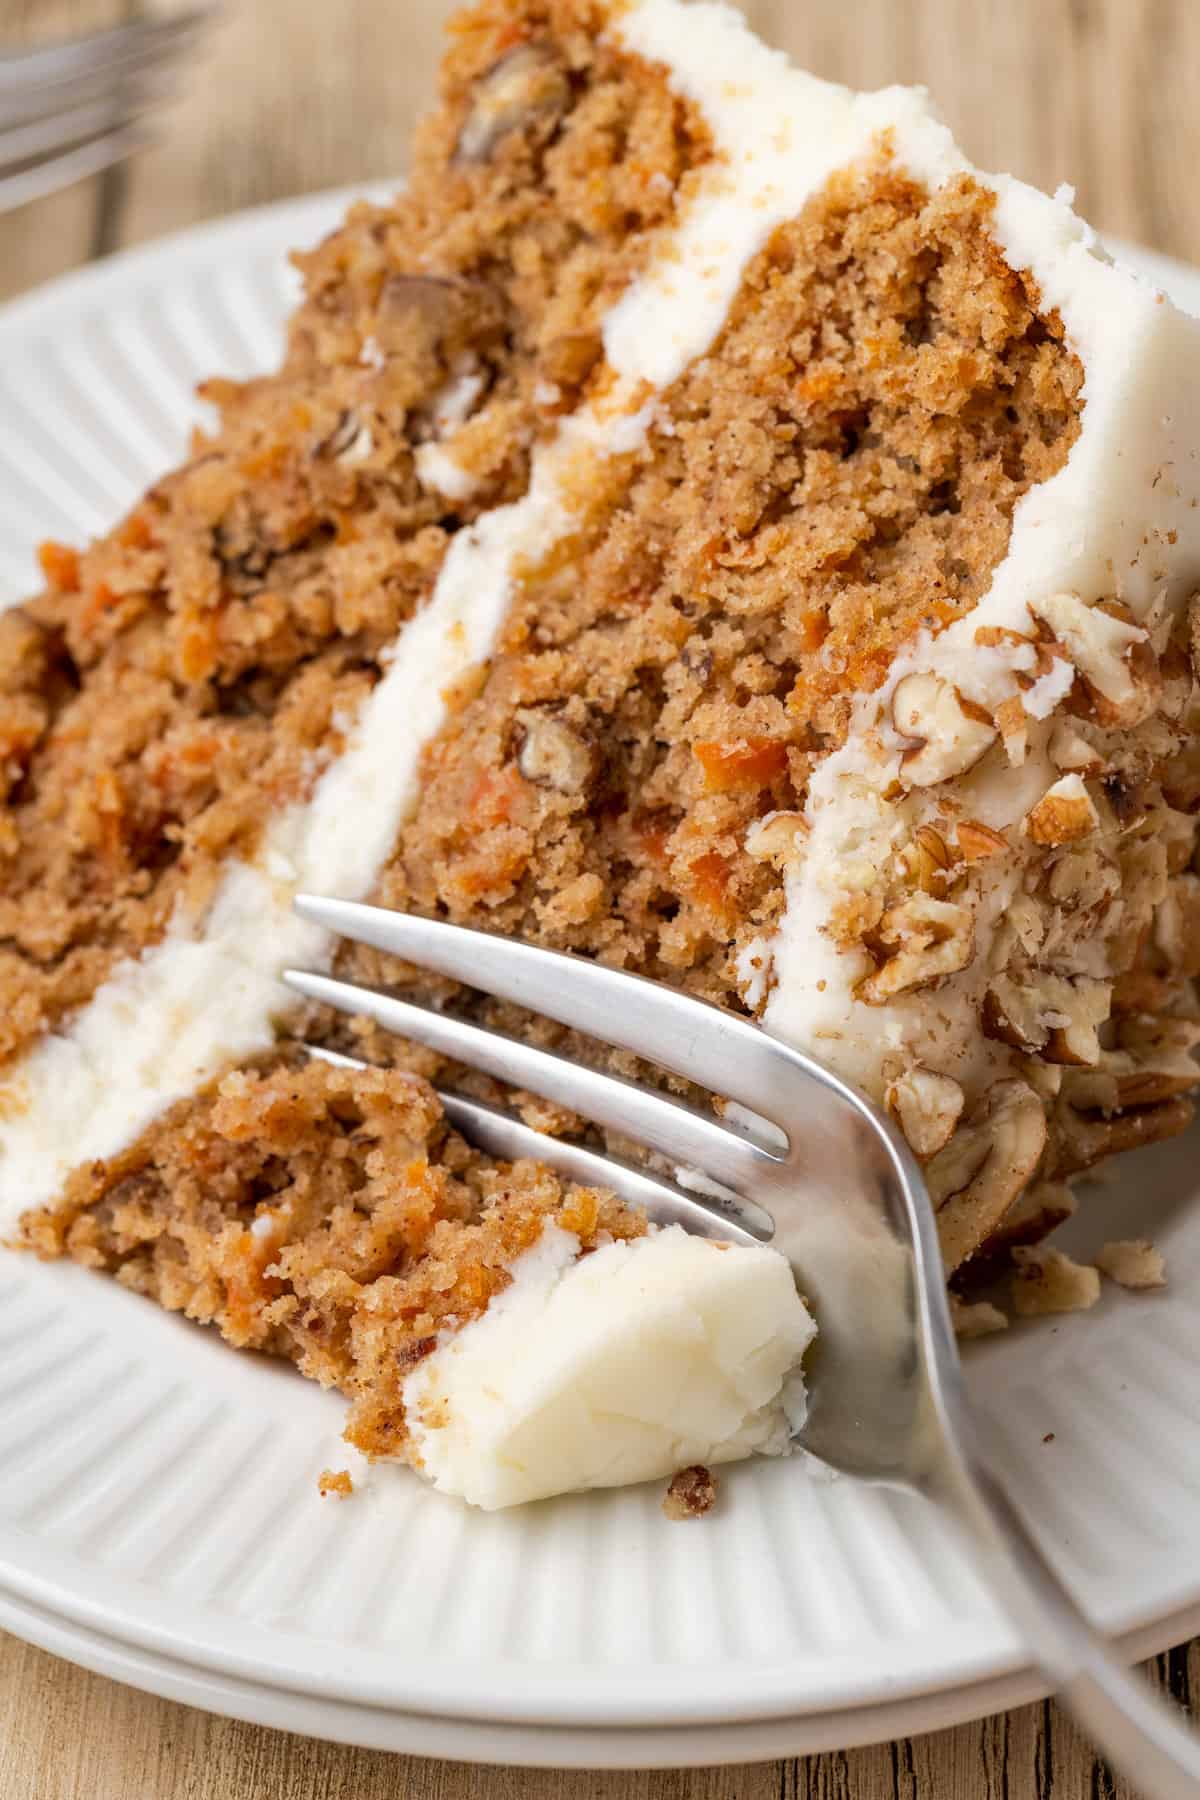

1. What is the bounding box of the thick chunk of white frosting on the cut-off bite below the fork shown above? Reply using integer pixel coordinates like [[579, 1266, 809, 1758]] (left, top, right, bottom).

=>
[[405, 1226, 813, 1510]]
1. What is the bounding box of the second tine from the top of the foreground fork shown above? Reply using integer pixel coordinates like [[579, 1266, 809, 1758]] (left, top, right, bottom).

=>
[[282, 968, 779, 1193]]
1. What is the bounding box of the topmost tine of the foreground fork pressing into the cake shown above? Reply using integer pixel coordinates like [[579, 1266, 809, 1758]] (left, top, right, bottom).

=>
[[295, 895, 813, 1123]]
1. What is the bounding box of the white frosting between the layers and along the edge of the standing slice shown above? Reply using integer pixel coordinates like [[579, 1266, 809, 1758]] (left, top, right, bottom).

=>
[[9, 0, 1200, 1222]]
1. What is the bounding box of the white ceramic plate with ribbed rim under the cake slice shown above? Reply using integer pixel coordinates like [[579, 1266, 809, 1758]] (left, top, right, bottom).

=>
[[0, 196, 1200, 1766]]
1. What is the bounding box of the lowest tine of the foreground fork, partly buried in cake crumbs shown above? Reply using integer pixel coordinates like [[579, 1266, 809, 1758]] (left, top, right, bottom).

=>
[[304, 1044, 772, 1246]]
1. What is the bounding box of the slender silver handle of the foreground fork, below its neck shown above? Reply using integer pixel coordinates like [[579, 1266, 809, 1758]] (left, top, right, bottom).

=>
[[939, 1433, 1200, 1800]]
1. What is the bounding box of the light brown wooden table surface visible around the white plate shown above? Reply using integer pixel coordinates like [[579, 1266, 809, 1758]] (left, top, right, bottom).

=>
[[0, 0, 1200, 1800]]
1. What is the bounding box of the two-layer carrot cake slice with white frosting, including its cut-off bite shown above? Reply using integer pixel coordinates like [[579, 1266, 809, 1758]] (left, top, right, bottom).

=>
[[0, 0, 1200, 1505]]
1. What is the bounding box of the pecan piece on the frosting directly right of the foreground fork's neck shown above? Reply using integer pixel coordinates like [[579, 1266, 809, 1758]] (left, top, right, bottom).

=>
[[925, 1080, 1045, 1269]]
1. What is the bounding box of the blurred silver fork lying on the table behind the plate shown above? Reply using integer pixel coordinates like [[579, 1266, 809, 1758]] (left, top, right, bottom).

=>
[[0, 7, 214, 211]]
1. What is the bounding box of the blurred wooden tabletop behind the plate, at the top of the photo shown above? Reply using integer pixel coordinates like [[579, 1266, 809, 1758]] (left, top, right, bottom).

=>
[[0, 0, 1200, 297]]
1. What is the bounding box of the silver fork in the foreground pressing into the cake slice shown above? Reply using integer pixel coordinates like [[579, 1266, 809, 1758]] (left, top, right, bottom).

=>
[[284, 895, 1200, 1800]]
